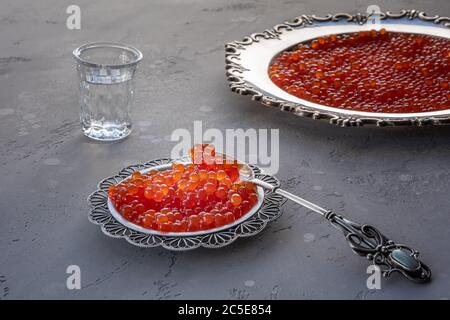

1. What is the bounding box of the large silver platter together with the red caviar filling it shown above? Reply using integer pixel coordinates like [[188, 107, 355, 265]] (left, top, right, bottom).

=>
[[226, 10, 450, 126]]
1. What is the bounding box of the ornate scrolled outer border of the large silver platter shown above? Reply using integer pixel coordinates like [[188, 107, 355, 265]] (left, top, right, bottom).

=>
[[225, 9, 450, 127]]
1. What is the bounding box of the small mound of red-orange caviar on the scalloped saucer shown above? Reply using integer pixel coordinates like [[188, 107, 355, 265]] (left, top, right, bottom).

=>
[[109, 145, 258, 232]]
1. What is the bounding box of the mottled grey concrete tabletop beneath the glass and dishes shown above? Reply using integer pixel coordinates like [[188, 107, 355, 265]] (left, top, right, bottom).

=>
[[0, 0, 450, 299]]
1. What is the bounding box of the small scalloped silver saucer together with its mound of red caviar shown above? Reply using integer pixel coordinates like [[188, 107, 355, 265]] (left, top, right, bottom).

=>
[[88, 145, 284, 250]]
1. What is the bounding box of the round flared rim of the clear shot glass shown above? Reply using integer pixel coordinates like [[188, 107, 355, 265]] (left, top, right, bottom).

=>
[[72, 42, 143, 68]]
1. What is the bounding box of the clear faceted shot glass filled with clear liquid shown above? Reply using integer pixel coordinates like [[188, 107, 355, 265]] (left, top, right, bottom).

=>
[[73, 42, 142, 141]]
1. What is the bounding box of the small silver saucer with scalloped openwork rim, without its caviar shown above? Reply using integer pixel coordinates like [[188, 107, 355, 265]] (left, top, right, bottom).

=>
[[88, 158, 284, 250]]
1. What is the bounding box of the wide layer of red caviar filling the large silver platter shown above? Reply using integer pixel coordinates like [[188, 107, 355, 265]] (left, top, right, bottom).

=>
[[269, 29, 450, 113]]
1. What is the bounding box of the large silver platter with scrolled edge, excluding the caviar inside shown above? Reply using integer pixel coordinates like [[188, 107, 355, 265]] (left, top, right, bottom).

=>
[[226, 10, 450, 126]]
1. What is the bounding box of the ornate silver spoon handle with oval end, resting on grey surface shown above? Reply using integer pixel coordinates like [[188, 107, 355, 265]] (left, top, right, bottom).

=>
[[252, 179, 431, 283]]
